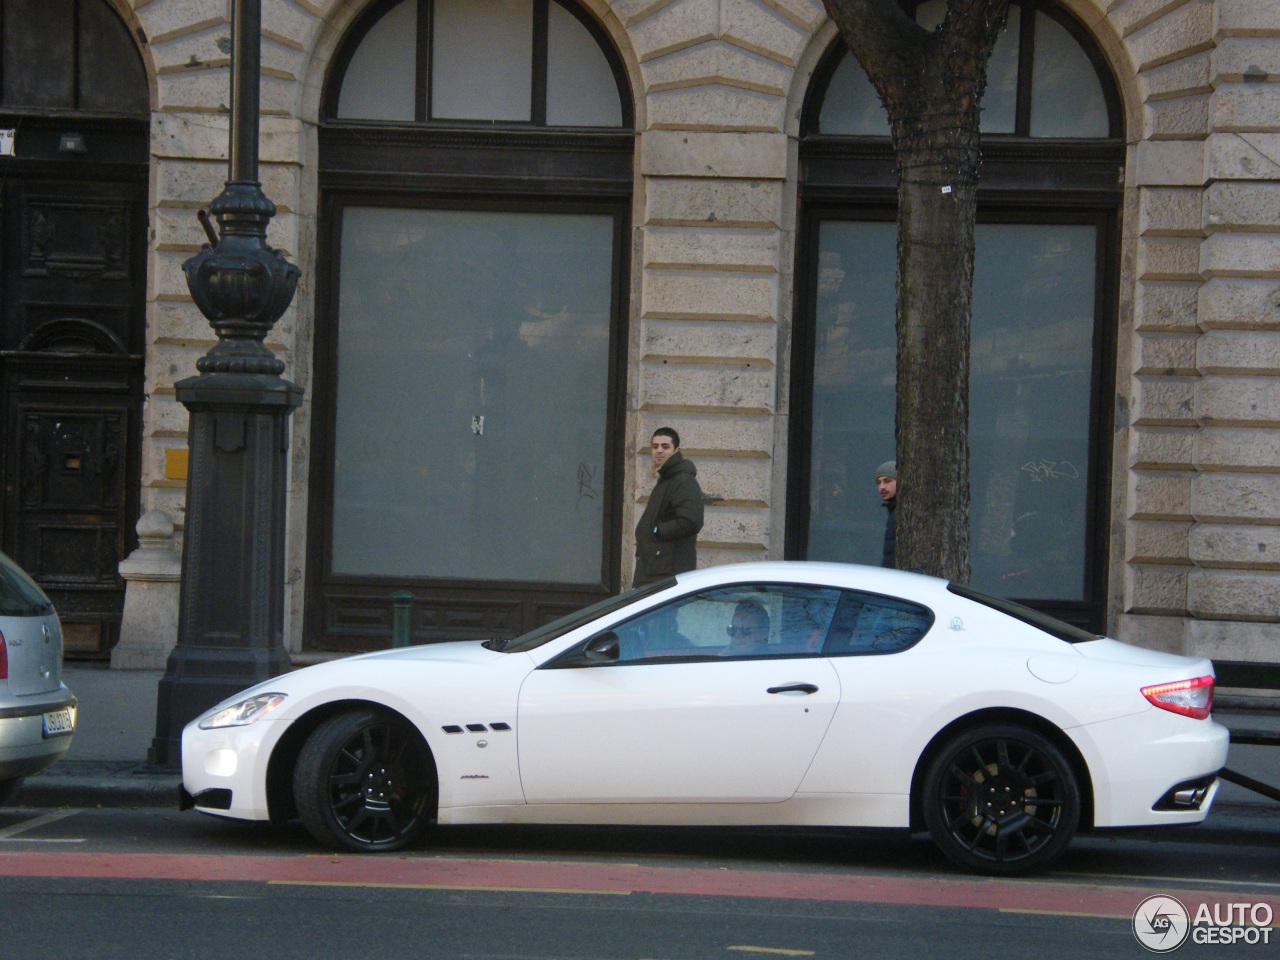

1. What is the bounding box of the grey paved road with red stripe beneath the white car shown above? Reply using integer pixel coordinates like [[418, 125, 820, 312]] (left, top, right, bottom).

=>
[[0, 809, 1280, 960]]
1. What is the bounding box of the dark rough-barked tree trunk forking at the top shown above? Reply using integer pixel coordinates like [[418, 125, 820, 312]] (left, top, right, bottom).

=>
[[824, 0, 1009, 581]]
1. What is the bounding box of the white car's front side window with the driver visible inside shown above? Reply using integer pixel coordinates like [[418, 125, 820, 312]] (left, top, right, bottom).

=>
[[613, 584, 840, 663]]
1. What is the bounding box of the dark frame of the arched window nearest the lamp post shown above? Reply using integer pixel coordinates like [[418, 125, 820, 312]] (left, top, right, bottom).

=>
[[303, 0, 636, 652]]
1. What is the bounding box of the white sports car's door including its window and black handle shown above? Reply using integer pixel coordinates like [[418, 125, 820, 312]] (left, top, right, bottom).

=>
[[518, 584, 840, 804]]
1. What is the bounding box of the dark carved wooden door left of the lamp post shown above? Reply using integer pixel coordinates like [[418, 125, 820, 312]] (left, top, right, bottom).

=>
[[0, 177, 146, 658]]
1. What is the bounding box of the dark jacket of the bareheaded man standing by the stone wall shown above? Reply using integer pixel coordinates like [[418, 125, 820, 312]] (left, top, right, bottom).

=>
[[632, 452, 703, 586]]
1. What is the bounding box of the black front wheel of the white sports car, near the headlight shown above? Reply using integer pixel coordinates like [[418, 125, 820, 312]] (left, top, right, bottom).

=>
[[293, 710, 436, 852]]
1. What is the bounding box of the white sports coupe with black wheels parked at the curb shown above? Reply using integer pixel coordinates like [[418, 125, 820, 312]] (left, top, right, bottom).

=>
[[182, 562, 1228, 874]]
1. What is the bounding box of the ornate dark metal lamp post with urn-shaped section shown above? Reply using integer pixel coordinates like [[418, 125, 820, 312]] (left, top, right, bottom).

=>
[[148, 0, 302, 768]]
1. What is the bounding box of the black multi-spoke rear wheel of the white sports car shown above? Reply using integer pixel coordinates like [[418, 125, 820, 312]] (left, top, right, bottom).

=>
[[923, 723, 1080, 877]]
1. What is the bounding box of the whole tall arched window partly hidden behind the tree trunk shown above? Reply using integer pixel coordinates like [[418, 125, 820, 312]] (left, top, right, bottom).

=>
[[787, 0, 1124, 628]]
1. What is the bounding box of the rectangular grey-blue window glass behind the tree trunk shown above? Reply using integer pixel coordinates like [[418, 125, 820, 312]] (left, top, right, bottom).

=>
[[808, 220, 1098, 600]]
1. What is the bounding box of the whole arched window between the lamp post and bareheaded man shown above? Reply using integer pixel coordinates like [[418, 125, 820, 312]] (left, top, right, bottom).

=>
[[307, 0, 634, 649]]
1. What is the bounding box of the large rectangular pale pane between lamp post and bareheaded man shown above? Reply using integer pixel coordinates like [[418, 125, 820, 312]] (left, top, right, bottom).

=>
[[333, 207, 614, 584]]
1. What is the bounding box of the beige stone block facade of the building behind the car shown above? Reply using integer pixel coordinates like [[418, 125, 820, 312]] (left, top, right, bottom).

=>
[[5, 0, 1280, 662]]
